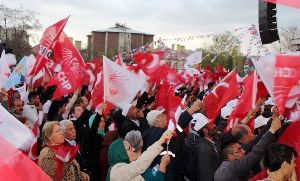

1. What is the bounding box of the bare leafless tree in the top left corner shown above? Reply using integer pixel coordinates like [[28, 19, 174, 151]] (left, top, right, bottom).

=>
[[0, 4, 41, 58]]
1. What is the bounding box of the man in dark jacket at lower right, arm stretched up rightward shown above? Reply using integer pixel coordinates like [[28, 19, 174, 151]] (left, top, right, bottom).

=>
[[214, 118, 281, 181]]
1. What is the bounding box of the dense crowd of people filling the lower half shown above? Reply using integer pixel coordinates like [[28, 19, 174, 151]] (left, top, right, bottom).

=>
[[0, 76, 297, 181]]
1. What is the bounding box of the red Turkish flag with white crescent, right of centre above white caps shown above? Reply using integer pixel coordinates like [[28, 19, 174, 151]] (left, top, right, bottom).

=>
[[203, 71, 240, 121]]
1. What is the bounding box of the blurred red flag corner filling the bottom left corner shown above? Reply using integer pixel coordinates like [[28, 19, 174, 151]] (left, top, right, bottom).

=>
[[0, 137, 52, 181]]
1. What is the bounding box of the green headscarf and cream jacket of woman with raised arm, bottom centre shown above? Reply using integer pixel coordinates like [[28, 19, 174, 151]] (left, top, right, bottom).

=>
[[106, 139, 163, 181]]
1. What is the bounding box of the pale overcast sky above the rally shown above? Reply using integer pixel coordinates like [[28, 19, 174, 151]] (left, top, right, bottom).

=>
[[0, 0, 300, 51]]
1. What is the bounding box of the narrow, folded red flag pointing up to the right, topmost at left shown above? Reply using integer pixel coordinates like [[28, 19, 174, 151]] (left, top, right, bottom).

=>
[[30, 17, 69, 75]]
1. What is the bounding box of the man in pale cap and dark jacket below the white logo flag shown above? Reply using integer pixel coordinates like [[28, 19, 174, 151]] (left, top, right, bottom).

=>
[[119, 101, 149, 138]]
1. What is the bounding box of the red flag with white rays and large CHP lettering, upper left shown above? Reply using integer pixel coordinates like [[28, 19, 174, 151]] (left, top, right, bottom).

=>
[[48, 33, 85, 99]]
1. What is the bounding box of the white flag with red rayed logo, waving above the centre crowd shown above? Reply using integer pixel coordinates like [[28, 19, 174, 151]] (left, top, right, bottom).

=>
[[103, 56, 145, 108]]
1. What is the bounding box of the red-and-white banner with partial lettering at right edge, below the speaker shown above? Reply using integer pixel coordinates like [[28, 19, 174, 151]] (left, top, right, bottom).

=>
[[253, 54, 300, 115]]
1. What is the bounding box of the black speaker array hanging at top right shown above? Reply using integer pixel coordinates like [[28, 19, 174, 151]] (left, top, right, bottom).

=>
[[258, 0, 279, 44]]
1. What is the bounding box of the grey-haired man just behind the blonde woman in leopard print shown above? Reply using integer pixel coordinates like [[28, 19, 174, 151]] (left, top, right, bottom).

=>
[[59, 120, 86, 177]]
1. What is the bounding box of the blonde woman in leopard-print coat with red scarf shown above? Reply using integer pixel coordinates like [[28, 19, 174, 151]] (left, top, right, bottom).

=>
[[38, 121, 89, 181]]
